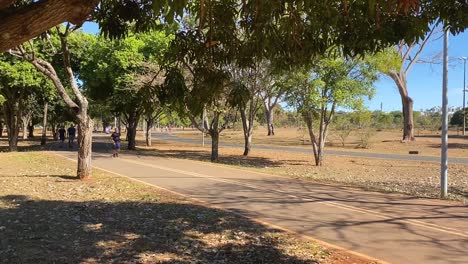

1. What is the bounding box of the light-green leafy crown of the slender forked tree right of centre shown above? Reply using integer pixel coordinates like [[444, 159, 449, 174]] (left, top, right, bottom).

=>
[[287, 54, 377, 114]]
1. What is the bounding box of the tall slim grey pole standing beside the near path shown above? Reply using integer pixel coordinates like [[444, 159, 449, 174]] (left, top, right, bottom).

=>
[[440, 26, 449, 198]]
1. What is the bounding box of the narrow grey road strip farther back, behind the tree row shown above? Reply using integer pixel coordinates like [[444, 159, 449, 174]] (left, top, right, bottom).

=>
[[152, 133, 468, 164]]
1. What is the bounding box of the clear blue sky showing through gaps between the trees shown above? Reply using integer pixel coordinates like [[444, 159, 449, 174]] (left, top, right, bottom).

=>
[[83, 23, 468, 111]]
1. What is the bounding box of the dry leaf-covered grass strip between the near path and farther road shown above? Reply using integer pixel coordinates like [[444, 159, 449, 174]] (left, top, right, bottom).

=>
[[133, 137, 468, 204]]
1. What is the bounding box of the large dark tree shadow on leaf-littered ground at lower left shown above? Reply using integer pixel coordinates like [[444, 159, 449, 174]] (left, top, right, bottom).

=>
[[0, 195, 316, 264]]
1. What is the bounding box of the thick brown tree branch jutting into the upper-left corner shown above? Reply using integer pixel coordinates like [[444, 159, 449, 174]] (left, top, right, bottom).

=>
[[0, 0, 99, 51]]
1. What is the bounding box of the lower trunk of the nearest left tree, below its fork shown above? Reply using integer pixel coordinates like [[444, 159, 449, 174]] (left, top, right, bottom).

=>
[[77, 115, 93, 180]]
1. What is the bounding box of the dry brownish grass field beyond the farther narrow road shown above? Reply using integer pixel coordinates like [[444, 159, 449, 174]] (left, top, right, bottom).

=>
[[171, 127, 468, 157]]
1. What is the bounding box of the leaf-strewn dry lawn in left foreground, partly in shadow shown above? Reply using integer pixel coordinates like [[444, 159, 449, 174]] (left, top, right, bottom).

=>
[[0, 152, 368, 263]]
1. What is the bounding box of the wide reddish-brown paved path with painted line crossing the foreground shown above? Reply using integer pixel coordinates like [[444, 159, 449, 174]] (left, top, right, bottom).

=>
[[51, 138, 468, 264]]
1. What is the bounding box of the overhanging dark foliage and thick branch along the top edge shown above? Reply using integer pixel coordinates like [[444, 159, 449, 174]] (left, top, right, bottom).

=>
[[0, 0, 468, 56]]
